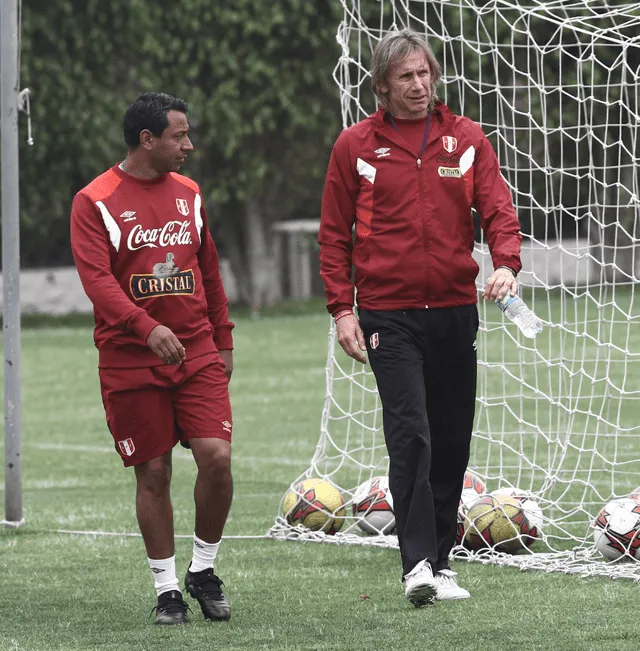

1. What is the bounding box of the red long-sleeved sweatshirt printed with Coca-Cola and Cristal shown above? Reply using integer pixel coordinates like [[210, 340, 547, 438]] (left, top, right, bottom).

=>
[[71, 165, 233, 368]]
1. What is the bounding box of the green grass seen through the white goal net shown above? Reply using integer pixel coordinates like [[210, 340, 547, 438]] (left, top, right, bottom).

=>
[[318, 288, 640, 549]]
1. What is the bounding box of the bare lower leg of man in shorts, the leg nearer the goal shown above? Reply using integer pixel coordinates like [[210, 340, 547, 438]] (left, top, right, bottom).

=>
[[189, 438, 233, 543]]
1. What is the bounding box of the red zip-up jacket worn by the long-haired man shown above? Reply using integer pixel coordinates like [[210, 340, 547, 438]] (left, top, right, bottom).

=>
[[318, 103, 522, 314]]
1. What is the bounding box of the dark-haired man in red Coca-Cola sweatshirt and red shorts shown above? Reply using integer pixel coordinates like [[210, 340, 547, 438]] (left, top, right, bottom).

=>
[[71, 93, 233, 624]]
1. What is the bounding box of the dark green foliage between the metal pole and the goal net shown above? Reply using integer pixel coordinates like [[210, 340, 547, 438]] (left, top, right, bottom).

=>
[[20, 0, 342, 304]]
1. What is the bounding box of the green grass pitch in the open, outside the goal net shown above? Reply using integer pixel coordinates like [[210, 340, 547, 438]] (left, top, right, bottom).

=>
[[0, 304, 640, 651]]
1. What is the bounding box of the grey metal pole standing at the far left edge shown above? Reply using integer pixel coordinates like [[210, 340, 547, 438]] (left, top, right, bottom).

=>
[[0, 0, 22, 527]]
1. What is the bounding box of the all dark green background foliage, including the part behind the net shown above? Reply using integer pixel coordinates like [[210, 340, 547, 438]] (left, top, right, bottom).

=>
[[11, 0, 640, 310]]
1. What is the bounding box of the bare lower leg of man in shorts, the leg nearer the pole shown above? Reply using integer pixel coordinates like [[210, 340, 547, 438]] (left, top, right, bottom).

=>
[[135, 451, 175, 559]]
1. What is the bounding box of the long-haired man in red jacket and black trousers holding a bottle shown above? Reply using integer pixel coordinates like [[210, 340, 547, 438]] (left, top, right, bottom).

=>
[[318, 29, 522, 606]]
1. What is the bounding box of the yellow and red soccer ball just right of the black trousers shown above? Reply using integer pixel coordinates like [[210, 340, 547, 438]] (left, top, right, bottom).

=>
[[463, 495, 538, 554]]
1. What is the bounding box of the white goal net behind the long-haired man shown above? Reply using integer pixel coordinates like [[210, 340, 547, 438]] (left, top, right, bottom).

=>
[[269, 0, 640, 579]]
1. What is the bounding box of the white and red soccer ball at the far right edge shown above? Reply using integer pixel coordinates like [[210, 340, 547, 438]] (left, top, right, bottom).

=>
[[593, 497, 640, 560]]
